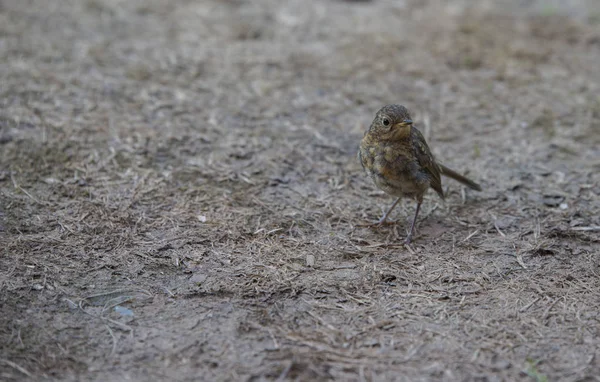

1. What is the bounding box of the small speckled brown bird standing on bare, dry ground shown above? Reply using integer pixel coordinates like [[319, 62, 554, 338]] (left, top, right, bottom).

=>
[[358, 104, 481, 244]]
